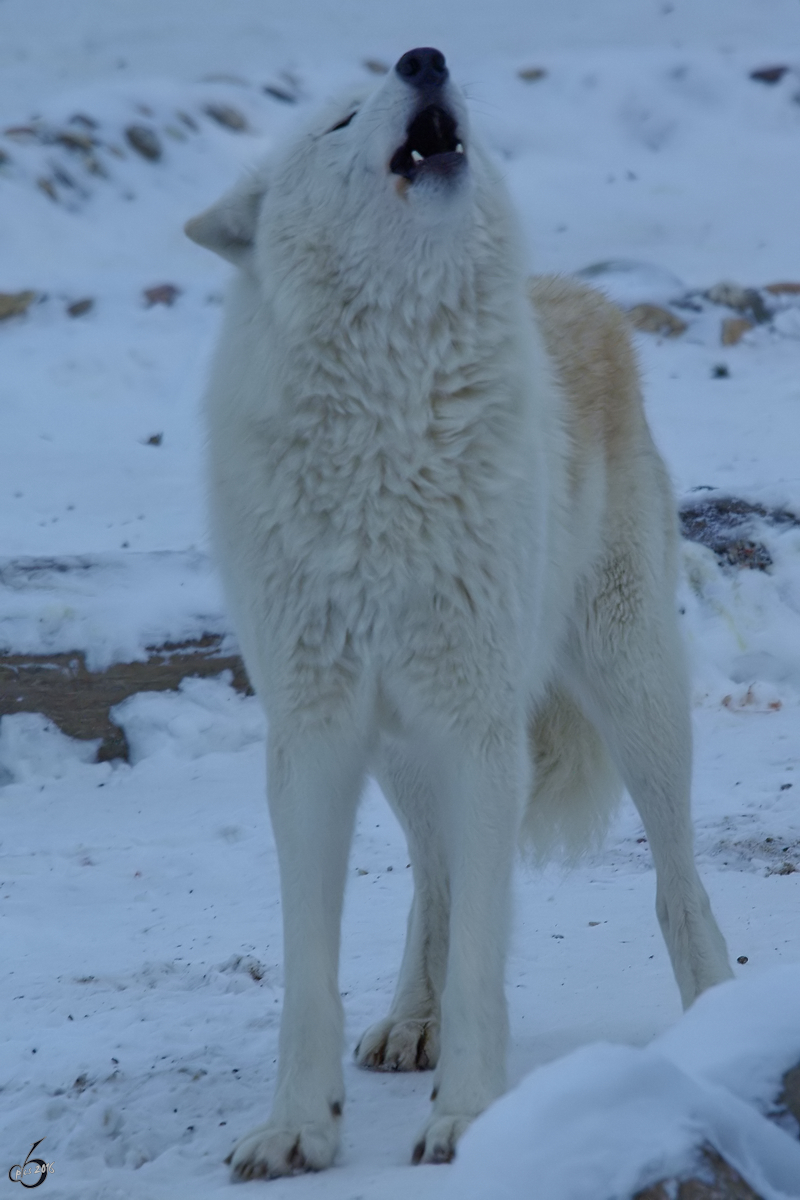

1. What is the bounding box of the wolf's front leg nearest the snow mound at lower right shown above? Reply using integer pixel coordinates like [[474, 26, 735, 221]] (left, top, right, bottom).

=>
[[414, 730, 528, 1163]]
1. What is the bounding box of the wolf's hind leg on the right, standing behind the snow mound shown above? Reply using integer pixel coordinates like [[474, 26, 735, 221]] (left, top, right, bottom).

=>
[[572, 554, 732, 1008]]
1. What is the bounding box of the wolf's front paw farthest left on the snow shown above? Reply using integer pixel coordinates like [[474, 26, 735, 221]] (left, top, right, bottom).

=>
[[225, 1117, 339, 1181]]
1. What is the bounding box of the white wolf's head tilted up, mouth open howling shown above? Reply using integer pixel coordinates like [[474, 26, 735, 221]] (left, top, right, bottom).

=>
[[186, 48, 509, 295]]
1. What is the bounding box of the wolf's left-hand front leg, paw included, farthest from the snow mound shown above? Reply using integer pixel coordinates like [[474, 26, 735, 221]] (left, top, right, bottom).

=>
[[230, 720, 365, 1180]]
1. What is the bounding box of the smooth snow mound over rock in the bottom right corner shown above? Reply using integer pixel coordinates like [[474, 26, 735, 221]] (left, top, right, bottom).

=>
[[445, 966, 800, 1200]]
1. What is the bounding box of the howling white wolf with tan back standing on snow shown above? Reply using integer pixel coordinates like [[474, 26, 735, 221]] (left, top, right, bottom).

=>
[[187, 49, 730, 1178]]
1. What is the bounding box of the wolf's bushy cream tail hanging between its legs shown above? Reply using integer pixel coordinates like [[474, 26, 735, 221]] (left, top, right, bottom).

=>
[[519, 688, 622, 863]]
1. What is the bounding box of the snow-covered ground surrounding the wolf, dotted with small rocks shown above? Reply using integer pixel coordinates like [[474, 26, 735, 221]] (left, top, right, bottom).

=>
[[0, 0, 800, 1200]]
